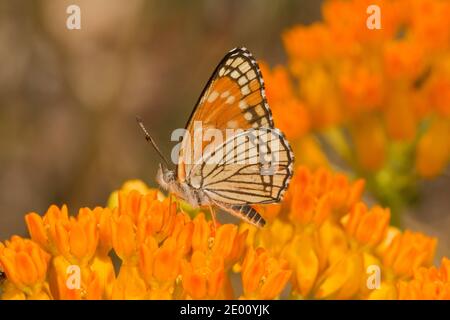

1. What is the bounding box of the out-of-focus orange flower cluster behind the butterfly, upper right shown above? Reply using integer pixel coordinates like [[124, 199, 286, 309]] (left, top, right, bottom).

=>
[[262, 0, 450, 215]]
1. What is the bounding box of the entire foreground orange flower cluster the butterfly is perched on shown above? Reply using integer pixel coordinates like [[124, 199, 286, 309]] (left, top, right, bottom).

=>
[[0, 167, 450, 299]]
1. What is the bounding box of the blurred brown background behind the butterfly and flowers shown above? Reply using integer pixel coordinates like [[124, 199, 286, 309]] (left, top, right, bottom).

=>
[[0, 0, 450, 259]]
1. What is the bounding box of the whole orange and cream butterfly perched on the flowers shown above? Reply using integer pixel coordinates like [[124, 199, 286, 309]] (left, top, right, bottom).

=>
[[138, 47, 294, 227]]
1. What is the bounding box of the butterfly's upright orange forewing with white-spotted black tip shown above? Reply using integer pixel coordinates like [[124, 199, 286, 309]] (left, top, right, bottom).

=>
[[177, 48, 274, 181]]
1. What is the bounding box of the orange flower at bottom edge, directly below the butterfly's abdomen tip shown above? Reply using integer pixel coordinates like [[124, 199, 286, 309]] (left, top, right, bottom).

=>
[[242, 248, 291, 300]]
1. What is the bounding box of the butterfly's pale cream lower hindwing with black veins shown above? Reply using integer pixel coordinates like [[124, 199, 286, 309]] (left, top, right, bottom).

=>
[[187, 128, 294, 206]]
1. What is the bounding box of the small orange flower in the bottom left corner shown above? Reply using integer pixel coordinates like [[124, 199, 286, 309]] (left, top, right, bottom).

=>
[[0, 236, 50, 299]]
